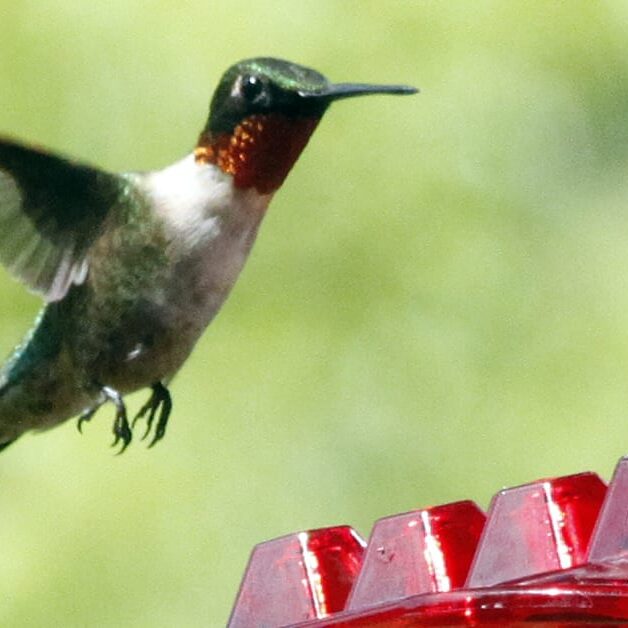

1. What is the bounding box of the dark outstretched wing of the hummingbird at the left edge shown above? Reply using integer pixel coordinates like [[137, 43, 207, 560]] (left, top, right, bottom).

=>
[[0, 139, 124, 301]]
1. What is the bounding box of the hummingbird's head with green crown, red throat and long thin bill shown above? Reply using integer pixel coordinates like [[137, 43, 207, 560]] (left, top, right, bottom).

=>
[[195, 58, 417, 194]]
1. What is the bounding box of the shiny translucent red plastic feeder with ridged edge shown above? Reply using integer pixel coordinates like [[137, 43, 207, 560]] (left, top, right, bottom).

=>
[[229, 457, 628, 628]]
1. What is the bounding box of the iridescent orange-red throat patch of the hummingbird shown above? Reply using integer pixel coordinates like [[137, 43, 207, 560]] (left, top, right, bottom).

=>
[[194, 113, 320, 194]]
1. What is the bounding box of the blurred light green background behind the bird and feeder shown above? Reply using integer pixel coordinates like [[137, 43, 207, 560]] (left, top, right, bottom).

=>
[[0, 0, 628, 627]]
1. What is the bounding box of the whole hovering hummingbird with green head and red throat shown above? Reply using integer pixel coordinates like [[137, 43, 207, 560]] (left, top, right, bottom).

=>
[[0, 57, 417, 453]]
